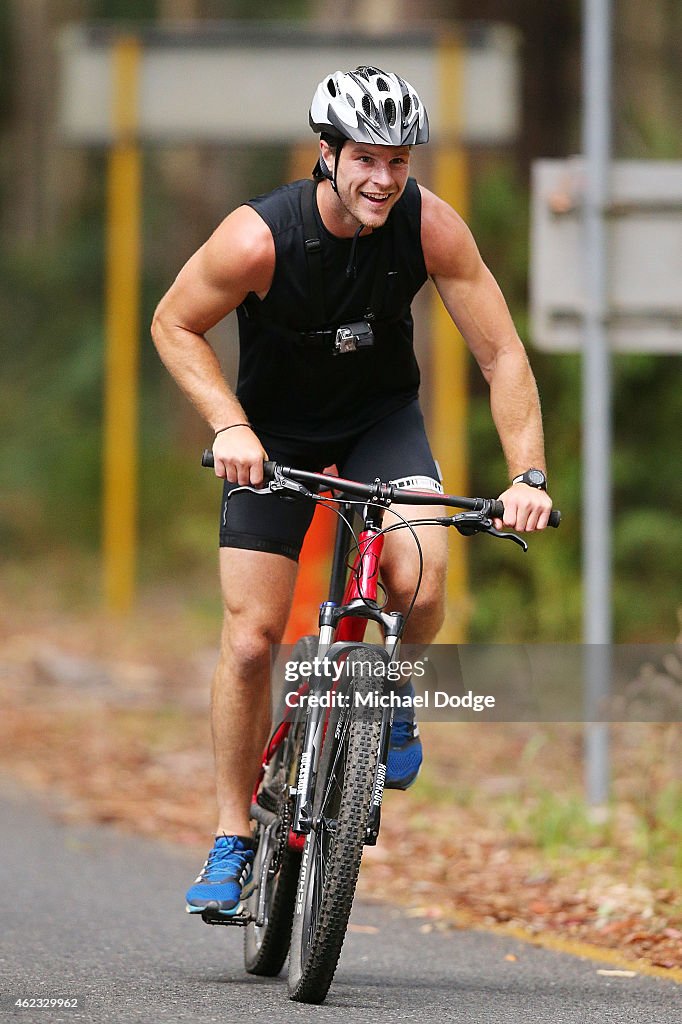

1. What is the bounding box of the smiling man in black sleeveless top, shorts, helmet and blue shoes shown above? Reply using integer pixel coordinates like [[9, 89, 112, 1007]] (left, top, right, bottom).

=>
[[153, 68, 552, 916]]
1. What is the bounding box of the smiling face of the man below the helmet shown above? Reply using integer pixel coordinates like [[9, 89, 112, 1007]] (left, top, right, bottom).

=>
[[321, 140, 410, 232]]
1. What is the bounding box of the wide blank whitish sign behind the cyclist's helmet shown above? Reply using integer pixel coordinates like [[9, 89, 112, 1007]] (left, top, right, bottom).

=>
[[58, 23, 519, 144]]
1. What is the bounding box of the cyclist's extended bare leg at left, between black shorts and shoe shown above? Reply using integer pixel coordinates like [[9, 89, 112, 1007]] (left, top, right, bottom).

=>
[[211, 548, 298, 836]]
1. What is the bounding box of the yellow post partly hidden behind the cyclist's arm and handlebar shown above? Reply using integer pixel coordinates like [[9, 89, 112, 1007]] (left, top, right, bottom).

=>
[[431, 37, 469, 643]]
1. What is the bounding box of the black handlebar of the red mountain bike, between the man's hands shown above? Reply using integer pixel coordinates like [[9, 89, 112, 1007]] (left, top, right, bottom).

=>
[[202, 449, 561, 528]]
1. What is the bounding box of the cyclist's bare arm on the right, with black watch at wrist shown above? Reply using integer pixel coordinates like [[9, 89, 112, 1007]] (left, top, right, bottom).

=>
[[422, 188, 552, 529]]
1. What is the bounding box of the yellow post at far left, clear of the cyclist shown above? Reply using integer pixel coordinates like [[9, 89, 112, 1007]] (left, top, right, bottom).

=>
[[103, 37, 141, 611]]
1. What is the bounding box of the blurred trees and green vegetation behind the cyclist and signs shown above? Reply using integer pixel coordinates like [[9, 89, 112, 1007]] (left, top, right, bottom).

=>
[[0, 0, 682, 642]]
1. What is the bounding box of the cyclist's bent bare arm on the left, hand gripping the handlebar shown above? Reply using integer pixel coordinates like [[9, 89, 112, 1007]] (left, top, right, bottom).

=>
[[152, 207, 274, 484]]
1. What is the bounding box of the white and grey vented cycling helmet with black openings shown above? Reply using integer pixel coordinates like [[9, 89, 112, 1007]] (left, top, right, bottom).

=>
[[309, 67, 429, 145]]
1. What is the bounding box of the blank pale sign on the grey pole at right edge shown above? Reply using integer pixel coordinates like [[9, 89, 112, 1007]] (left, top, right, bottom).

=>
[[530, 159, 682, 352]]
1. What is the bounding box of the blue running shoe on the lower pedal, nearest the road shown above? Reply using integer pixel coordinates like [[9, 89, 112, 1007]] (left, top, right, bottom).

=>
[[186, 836, 255, 916]]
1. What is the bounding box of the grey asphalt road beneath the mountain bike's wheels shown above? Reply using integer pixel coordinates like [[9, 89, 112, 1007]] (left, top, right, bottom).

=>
[[0, 787, 682, 1024]]
